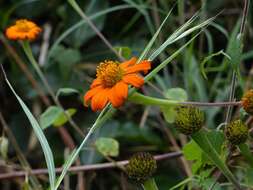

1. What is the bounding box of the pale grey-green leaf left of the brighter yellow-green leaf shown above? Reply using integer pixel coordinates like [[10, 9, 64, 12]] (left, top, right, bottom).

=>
[[39, 106, 63, 129]]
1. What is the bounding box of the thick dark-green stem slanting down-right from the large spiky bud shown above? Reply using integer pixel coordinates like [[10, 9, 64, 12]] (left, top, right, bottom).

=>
[[191, 131, 241, 190]]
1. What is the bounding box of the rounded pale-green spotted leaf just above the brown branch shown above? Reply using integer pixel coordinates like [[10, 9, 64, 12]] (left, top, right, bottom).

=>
[[95, 137, 119, 156]]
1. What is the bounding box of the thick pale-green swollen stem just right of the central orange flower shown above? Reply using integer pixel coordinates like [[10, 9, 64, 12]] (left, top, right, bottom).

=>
[[128, 92, 179, 106]]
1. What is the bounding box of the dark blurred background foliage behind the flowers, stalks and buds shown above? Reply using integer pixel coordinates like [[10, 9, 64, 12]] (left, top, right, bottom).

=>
[[0, 0, 253, 190]]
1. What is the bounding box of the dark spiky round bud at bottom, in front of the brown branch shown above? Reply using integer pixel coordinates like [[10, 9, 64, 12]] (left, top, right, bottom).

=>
[[126, 152, 157, 182]]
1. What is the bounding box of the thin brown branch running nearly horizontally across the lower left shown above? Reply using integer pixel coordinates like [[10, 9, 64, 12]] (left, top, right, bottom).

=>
[[0, 151, 182, 180]]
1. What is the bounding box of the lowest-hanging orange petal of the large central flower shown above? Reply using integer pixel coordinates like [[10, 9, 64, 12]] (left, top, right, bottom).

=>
[[91, 89, 108, 111]]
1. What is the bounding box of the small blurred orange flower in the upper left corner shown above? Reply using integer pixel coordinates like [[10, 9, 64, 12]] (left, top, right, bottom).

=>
[[5, 19, 41, 40]]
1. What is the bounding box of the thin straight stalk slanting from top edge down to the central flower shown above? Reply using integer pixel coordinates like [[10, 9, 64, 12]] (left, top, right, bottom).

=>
[[68, 0, 124, 61]]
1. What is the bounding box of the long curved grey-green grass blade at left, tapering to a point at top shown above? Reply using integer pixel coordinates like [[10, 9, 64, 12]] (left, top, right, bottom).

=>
[[2, 68, 55, 189]]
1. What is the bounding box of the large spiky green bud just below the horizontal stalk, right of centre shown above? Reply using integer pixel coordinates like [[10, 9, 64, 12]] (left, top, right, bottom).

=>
[[175, 107, 204, 135]]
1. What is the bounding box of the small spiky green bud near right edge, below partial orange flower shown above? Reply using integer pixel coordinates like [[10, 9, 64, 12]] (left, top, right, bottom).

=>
[[225, 120, 249, 145]]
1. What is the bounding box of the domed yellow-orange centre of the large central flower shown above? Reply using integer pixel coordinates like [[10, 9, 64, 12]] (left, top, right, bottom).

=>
[[97, 61, 124, 87]]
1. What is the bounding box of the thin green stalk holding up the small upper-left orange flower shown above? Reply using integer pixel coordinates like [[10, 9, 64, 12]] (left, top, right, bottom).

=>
[[21, 41, 84, 137]]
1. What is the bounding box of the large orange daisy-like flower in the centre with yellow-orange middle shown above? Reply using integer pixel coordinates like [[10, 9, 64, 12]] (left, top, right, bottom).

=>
[[84, 57, 151, 111]]
